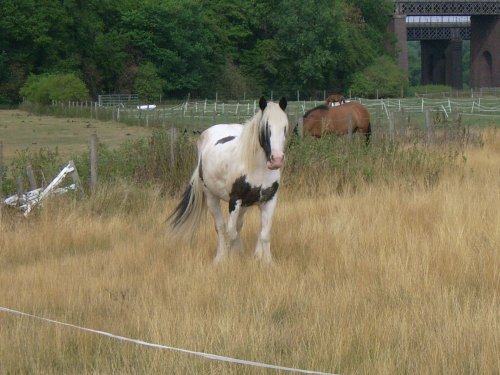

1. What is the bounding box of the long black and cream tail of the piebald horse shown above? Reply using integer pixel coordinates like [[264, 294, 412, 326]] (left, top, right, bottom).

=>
[[169, 159, 206, 238]]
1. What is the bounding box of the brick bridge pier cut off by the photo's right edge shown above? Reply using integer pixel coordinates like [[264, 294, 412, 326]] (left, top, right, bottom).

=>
[[470, 15, 500, 88]]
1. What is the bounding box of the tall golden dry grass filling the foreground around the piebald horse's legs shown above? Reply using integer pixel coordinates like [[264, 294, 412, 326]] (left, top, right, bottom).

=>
[[0, 130, 500, 374]]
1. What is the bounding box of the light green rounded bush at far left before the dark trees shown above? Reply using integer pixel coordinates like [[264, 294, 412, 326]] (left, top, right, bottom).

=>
[[20, 73, 89, 104]]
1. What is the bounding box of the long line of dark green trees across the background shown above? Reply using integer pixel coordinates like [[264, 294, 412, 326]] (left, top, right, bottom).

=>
[[0, 0, 406, 104]]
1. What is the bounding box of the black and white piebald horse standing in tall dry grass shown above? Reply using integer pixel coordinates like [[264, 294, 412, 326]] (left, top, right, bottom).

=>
[[170, 97, 288, 263]]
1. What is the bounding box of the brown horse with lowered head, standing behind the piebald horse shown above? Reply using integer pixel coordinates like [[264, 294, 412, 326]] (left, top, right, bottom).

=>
[[304, 102, 371, 144]]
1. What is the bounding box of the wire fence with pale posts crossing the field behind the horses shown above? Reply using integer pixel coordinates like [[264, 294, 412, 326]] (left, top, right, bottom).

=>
[[43, 96, 500, 138]]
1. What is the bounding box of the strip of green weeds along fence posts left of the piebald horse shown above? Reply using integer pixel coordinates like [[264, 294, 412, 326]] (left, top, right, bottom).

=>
[[2, 129, 197, 195]]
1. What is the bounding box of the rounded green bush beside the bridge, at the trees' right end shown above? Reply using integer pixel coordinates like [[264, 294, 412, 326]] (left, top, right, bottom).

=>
[[351, 56, 408, 98]]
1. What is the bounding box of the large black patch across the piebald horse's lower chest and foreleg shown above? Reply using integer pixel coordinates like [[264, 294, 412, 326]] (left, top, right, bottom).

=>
[[229, 175, 279, 212]]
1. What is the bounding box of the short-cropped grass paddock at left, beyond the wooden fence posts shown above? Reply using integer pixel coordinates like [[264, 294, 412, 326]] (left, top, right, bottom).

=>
[[0, 110, 151, 162]]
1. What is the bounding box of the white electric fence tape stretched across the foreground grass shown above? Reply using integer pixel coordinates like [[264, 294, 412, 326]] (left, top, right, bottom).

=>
[[0, 307, 334, 375]]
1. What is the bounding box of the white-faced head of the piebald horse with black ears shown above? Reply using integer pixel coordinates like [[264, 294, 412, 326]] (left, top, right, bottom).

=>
[[259, 97, 288, 169]]
